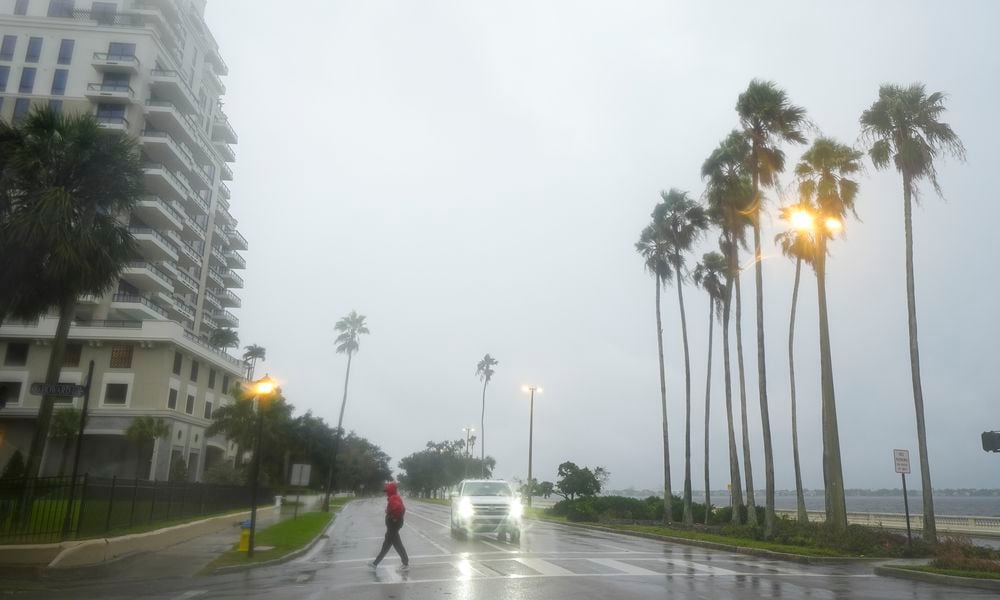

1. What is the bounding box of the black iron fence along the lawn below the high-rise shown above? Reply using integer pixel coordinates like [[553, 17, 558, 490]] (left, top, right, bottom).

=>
[[0, 475, 274, 544]]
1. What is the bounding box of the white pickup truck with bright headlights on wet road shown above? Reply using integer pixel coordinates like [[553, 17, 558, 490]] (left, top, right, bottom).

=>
[[451, 479, 524, 544]]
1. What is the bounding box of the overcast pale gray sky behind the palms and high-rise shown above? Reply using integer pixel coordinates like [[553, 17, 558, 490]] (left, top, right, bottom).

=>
[[207, 0, 1000, 489]]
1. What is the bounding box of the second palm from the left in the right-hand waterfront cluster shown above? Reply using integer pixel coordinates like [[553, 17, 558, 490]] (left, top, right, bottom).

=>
[[653, 189, 709, 527]]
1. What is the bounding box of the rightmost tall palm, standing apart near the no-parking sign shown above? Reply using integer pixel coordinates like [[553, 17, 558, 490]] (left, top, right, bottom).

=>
[[861, 83, 965, 542]]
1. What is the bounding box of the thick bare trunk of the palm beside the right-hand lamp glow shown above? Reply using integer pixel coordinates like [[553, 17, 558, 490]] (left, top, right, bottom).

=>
[[816, 236, 847, 531]]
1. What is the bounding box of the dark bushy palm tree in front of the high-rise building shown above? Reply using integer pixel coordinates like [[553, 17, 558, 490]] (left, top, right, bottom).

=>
[[0, 109, 143, 477]]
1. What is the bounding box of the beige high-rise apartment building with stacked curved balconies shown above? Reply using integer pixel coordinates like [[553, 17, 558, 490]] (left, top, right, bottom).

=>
[[0, 0, 247, 480]]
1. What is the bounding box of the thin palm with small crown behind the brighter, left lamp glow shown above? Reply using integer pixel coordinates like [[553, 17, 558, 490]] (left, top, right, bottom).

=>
[[774, 202, 815, 523]]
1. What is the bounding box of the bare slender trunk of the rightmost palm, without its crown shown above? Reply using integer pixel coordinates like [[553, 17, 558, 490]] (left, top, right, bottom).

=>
[[903, 174, 937, 543]]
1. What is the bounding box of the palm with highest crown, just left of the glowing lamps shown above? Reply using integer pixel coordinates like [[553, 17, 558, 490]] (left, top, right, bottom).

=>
[[736, 79, 806, 537]]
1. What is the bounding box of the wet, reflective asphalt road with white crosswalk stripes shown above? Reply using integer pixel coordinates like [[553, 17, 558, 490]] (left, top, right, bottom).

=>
[[11, 500, 996, 600]]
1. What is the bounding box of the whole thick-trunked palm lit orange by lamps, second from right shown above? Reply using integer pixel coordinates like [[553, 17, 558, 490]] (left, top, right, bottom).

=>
[[795, 137, 862, 531]]
